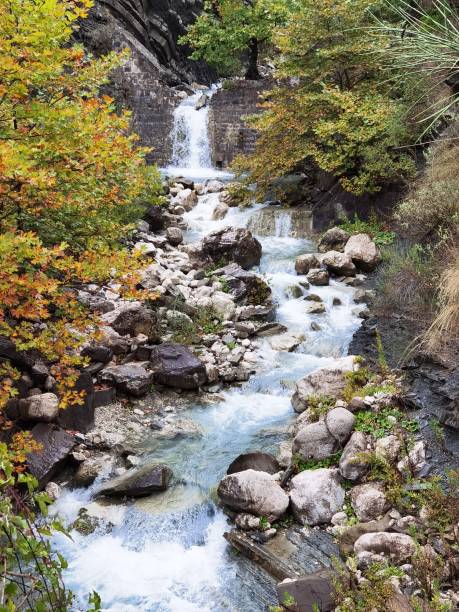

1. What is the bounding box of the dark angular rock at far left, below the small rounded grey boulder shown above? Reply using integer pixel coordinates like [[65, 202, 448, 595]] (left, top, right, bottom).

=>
[[27, 423, 75, 488]]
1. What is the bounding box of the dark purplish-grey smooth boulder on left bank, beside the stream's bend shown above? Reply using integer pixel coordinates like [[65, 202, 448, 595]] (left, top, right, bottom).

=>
[[150, 344, 207, 389]]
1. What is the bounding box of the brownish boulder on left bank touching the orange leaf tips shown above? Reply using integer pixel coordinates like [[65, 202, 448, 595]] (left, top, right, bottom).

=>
[[104, 304, 160, 342]]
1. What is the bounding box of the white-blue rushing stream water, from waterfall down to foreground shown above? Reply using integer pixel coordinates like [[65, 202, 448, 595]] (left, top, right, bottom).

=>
[[55, 86, 359, 612]]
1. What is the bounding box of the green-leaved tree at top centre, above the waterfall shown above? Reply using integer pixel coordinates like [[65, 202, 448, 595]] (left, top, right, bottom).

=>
[[180, 0, 289, 80]]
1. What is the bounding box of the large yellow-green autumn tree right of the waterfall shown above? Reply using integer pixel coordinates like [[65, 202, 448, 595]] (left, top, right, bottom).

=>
[[237, 0, 420, 194]]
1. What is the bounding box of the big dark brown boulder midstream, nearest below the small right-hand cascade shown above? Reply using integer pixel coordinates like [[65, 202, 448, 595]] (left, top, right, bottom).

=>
[[201, 227, 261, 269]]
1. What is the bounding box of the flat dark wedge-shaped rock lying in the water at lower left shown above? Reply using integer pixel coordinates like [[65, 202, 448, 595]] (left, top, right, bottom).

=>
[[98, 465, 172, 497]]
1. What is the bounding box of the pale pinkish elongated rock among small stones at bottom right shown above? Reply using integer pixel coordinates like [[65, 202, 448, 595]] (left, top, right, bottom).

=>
[[354, 531, 416, 564]]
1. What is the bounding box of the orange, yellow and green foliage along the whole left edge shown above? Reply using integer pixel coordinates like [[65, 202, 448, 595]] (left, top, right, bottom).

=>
[[0, 0, 164, 612]]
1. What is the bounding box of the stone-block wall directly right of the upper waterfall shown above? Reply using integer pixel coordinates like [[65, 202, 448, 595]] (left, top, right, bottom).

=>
[[209, 80, 268, 168]]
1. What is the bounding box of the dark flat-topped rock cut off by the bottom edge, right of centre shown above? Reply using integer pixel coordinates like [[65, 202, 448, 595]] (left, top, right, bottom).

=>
[[276, 570, 336, 612]]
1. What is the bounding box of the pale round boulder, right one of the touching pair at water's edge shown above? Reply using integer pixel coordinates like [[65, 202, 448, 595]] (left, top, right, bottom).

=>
[[290, 468, 344, 526]]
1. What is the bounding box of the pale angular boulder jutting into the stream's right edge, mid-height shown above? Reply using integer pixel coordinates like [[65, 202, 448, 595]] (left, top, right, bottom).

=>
[[292, 355, 355, 412]]
